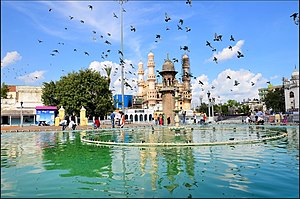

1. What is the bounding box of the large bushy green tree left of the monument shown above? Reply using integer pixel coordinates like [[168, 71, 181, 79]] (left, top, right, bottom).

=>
[[42, 69, 113, 116]]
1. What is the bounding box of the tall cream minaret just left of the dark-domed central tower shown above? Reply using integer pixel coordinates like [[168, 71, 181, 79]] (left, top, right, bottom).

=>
[[146, 52, 157, 109]]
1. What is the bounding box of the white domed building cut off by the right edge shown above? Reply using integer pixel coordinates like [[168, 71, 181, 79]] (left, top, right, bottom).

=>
[[283, 67, 299, 112]]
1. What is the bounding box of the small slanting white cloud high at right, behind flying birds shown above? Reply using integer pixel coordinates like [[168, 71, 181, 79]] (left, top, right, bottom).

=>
[[207, 40, 245, 62]]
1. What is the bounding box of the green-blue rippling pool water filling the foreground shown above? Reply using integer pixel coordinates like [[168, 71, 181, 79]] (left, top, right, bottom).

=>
[[1, 125, 299, 198]]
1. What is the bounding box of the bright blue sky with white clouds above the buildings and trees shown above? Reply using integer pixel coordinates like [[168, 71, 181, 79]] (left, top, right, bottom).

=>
[[1, 0, 299, 105]]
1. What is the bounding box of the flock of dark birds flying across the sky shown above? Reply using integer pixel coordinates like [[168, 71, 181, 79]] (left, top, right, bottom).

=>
[[4, 0, 299, 95]]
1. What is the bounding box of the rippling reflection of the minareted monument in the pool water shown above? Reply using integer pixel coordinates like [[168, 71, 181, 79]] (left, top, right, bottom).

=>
[[139, 132, 195, 192]]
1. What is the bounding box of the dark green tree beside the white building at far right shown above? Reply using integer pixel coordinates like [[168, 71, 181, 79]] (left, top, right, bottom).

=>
[[264, 88, 285, 112]]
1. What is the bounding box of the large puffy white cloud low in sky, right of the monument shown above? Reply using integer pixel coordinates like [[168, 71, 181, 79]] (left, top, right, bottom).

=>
[[191, 69, 266, 106]]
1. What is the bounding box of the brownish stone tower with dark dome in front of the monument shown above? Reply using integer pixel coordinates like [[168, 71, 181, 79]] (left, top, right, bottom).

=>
[[159, 56, 177, 124]]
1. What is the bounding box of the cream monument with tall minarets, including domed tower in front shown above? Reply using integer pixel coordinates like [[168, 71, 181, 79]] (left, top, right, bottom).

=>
[[137, 52, 192, 124]]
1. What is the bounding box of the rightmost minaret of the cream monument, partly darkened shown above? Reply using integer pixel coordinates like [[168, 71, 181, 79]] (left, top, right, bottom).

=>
[[182, 54, 192, 110]]
